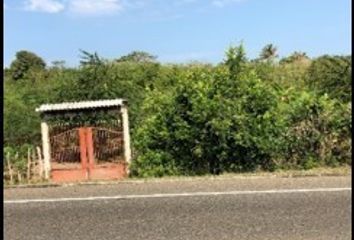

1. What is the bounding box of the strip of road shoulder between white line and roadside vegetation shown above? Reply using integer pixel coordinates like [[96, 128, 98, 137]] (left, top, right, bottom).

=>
[[4, 175, 351, 200]]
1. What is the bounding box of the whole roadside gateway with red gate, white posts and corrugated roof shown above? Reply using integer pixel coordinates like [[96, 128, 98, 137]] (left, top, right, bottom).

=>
[[36, 99, 131, 182]]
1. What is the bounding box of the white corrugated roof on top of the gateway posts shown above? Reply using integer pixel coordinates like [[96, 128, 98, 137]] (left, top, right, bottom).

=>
[[36, 99, 127, 112]]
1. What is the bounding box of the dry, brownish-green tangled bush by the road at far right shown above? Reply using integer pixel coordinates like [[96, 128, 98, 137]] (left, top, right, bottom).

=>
[[278, 91, 351, 168]]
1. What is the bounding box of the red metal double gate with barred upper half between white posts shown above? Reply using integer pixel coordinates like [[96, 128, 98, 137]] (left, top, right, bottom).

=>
[[51, 126, 126, 182]]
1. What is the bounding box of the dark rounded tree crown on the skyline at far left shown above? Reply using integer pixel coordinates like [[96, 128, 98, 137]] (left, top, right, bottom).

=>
[[10, 50, 46, 80]]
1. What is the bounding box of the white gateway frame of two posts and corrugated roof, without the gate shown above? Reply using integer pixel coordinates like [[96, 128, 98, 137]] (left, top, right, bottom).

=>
[[36, 99, 131, 180]]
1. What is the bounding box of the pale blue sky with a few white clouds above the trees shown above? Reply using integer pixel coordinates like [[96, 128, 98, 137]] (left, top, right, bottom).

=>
[[4, 0, 351, 66]]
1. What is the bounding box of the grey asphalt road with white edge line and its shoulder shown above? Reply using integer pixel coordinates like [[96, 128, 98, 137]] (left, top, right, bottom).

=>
[[4, 176, 352, 240]]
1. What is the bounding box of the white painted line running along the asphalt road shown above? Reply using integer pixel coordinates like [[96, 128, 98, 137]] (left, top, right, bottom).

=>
[[4, 187, 352, 204]]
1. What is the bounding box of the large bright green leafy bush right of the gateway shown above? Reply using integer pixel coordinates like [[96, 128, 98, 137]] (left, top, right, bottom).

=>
[[134, 54, 284, 175]]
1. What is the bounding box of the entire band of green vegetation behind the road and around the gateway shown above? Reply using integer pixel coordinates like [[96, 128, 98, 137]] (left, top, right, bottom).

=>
[[4, 44, 352, 182]]
